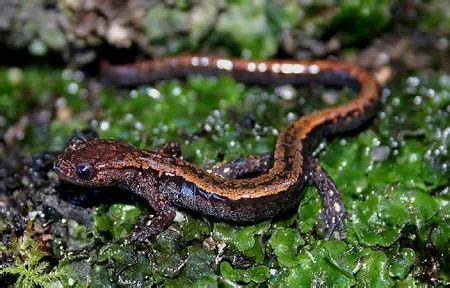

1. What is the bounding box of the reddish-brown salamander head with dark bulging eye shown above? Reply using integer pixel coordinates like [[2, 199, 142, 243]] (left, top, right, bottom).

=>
[[53, 137, 140, 186]]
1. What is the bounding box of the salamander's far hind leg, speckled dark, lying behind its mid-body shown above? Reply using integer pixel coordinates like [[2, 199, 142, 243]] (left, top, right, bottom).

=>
[[212, 153, 273, 179]]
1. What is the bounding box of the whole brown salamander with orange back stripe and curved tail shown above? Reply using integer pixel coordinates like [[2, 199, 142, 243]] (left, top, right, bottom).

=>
[[54, 55, 379, 241]]
